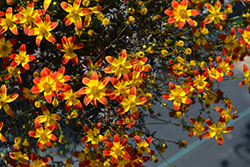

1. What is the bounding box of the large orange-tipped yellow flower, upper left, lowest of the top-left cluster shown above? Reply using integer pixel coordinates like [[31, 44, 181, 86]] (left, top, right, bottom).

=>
[[28, 14, 58, 47]]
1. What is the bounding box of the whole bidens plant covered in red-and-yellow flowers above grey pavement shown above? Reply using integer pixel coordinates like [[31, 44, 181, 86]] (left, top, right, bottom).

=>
[[0, 0, 250, 167]]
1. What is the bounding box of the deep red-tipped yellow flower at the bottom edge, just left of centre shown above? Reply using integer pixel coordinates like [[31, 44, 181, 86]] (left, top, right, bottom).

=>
[[103, 134, 131, 164]]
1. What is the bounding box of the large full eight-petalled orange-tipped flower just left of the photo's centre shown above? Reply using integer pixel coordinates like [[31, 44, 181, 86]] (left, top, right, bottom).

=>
[[78, 71, 114, 107]]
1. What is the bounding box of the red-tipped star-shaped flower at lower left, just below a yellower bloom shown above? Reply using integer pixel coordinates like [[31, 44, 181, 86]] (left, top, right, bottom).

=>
[[28, 121, 57, 148]]
